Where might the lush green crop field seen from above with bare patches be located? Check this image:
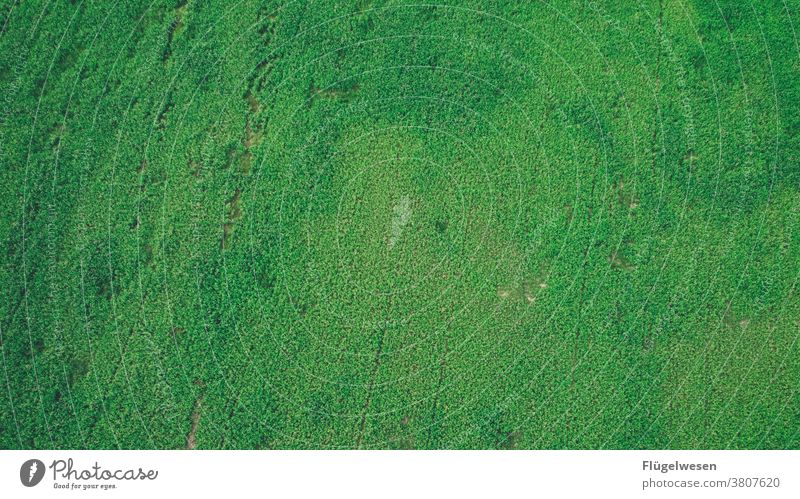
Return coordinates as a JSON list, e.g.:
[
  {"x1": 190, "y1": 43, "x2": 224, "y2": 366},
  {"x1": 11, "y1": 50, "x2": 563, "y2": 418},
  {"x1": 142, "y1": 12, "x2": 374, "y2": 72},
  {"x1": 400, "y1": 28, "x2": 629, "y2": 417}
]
[{"x1": 0, "y1": 0, "x2": 800, "y2": 449}]
